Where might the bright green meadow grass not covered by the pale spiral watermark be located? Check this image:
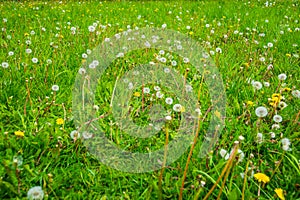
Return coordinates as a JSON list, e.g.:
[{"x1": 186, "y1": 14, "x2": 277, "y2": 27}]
[{"x1": 0, "y1": 0, "x2": 300, "y2": 199}]
